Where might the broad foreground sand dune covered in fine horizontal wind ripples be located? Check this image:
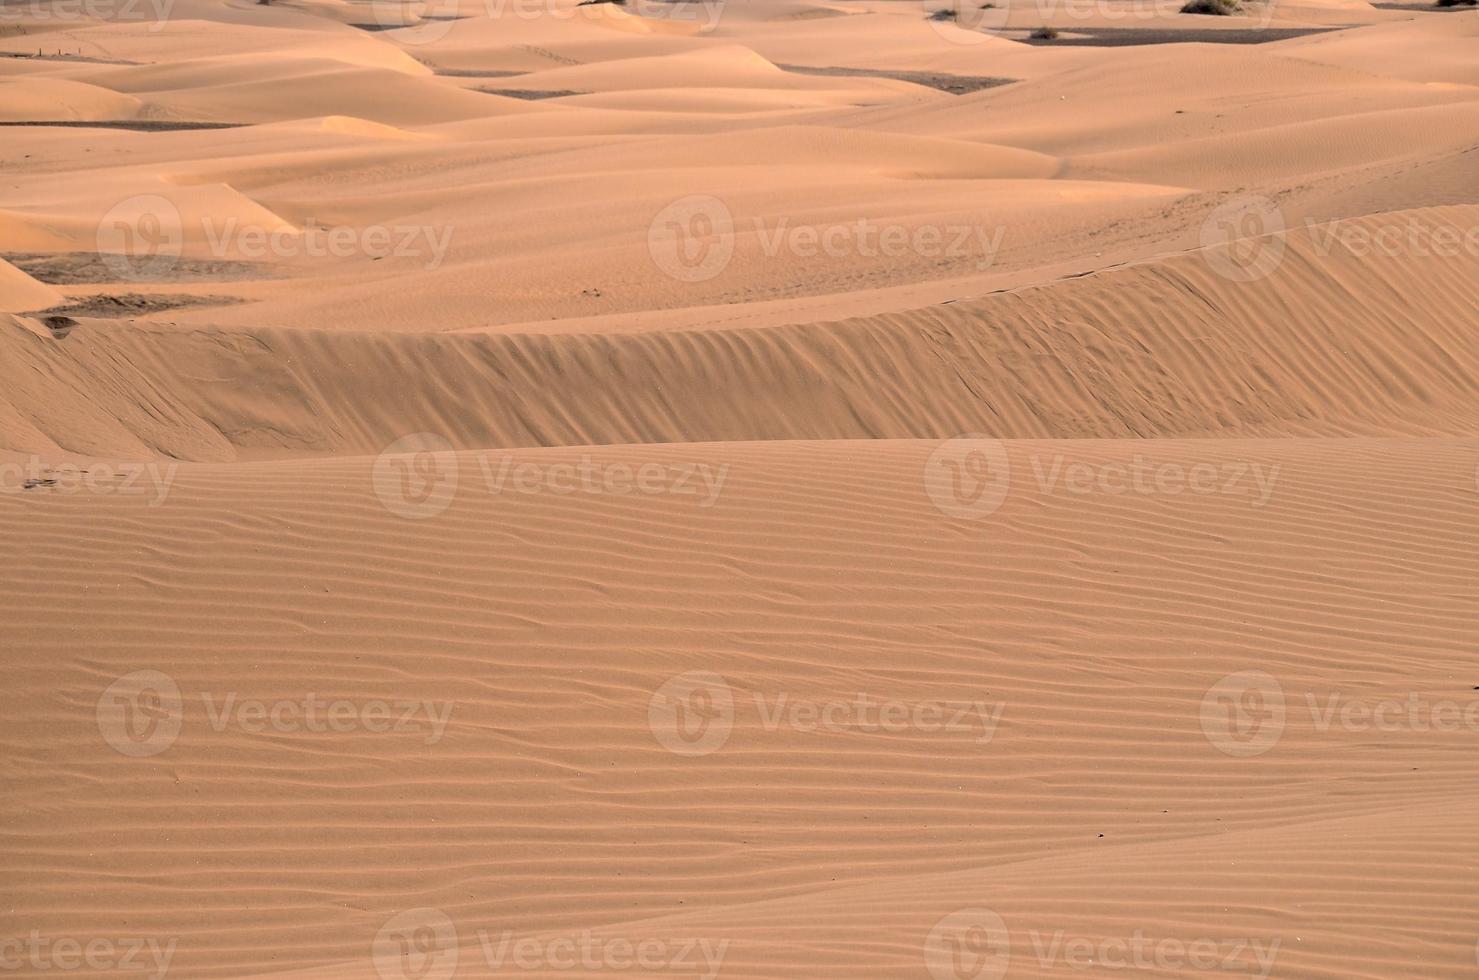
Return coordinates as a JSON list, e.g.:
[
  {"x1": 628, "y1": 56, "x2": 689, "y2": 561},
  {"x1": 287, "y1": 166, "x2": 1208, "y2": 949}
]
[{"x1": 0, "y1": 440, "x2": 1479, "y2": 977}]
